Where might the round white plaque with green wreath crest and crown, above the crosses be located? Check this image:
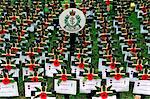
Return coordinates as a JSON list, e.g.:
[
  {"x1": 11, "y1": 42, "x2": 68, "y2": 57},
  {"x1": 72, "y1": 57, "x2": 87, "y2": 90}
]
[{"x1": 59, "y1": 8, "x2": 86, "y2": 33}]
